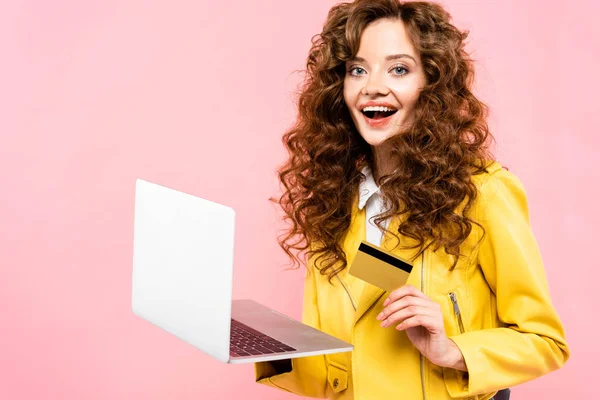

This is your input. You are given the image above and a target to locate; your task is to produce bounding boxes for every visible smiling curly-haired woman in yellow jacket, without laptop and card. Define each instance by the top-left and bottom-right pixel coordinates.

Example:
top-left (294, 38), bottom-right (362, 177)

top-left (256, 0), bottom-right (569, 400)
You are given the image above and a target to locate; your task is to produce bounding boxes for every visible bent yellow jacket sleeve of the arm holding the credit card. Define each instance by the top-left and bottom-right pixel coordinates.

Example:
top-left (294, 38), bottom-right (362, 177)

top-left (443, 169), bottom-right (570, 397)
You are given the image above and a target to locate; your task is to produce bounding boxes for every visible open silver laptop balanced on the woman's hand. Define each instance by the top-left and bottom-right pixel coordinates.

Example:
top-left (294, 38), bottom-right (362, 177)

top-left (132, 179), bottom-right (353, 364)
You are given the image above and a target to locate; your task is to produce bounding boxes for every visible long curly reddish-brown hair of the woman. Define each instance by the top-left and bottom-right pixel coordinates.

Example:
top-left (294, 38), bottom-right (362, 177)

top-left (276, 0), bottom-right (493, 279)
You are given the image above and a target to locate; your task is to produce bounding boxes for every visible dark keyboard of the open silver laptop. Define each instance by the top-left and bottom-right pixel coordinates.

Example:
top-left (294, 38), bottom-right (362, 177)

top-left (229, 319), bottom-right (296, 357)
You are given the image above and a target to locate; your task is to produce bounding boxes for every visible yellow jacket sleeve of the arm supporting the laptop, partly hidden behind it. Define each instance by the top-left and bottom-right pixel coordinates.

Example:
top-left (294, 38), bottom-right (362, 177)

top-left (255, 264), bottom-right (327, 398)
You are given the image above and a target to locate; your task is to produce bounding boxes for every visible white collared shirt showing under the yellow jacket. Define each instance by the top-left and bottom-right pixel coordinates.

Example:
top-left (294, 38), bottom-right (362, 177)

top-left (358, 167), bottom-right (390, 246)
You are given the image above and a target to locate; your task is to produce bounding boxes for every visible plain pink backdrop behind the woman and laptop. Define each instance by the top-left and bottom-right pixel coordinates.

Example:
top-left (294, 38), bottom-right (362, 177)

top-left (0, 0), bottom-right (600, 399)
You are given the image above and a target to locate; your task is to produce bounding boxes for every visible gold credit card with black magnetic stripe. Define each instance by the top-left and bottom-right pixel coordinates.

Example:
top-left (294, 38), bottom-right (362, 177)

top-left (348, 241), bottom-right (412, 292)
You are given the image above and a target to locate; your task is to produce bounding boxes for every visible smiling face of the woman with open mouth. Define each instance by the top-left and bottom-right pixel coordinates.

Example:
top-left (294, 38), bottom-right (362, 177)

top-left (344, 19), bottom-right (427, 147)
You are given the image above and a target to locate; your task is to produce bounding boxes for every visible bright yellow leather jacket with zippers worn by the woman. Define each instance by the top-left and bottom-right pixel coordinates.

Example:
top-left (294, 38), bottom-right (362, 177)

top-left (255, 163), bottom-right (569, 400)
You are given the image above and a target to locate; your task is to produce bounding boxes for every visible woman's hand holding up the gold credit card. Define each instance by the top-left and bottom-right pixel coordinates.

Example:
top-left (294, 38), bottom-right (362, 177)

top-left (377, 285), bottom-right (467, 371)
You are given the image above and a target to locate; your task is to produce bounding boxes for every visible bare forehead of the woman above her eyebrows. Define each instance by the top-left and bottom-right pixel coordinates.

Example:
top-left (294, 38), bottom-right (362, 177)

top-left (357, 19), bottom-right (419, 60)
